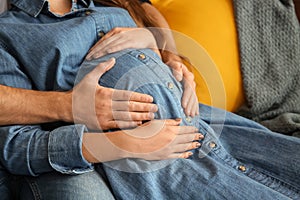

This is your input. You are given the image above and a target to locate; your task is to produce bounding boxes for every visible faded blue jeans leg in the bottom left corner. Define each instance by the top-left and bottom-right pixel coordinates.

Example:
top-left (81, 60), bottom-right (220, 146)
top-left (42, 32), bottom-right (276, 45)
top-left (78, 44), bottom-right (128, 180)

top-left (0, 170), bottom-right (114, 200)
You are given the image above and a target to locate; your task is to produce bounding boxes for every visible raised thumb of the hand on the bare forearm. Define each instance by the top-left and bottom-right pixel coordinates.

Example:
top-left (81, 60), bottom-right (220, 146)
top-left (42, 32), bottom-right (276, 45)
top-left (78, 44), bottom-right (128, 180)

top-left (87, 58), bottom-right (116, 81)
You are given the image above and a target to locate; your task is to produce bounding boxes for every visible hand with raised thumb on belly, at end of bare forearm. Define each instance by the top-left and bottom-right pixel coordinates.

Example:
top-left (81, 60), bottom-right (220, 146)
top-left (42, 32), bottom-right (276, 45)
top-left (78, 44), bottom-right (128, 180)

top-left (72, 59), bottom-right (158, 130)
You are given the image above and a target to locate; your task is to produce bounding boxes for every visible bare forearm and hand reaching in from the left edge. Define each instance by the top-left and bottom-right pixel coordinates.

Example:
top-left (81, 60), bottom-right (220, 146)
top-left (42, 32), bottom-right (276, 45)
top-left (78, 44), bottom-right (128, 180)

top-left (0, 62), bottom-right (157, 130)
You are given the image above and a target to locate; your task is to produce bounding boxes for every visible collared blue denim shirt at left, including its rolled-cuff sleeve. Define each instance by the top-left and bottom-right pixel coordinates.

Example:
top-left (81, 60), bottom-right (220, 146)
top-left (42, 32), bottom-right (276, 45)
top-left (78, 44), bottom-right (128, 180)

top-left (0, 0), bottom-right (135, 176)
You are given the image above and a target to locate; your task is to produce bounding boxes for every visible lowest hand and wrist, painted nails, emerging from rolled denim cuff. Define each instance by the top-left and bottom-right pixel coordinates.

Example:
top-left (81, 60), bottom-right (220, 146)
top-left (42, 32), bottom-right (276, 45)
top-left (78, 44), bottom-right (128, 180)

top-left (83, 120), bottom-right (204, 163)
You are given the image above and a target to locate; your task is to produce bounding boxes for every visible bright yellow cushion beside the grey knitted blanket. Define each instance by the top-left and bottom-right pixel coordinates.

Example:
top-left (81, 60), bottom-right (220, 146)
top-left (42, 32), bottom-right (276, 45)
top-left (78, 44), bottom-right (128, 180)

top-left (152, 0), bottom-right (244, 111)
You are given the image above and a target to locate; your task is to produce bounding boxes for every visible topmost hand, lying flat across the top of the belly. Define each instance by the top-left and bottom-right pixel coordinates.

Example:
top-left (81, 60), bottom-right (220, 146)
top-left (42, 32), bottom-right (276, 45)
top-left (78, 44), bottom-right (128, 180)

top-left (86, 28), bottom-right (160, 60)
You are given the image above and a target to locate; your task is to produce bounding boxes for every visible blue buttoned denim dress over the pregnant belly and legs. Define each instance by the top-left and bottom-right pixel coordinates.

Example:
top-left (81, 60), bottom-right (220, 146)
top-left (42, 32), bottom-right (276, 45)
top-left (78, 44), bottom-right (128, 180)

top-left (79, 50), bottom-right (300, 199)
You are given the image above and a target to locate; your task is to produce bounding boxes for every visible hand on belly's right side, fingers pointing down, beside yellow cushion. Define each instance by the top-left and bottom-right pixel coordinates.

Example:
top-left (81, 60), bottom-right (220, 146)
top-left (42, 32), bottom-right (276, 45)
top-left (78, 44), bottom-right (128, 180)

top-left (162, 51), bottom-right (199, 117)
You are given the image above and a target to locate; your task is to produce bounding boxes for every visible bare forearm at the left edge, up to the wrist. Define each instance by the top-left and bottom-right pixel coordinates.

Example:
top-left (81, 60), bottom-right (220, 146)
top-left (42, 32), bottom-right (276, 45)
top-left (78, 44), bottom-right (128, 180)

top-left (0, 85), bottom-right (73, 125)
